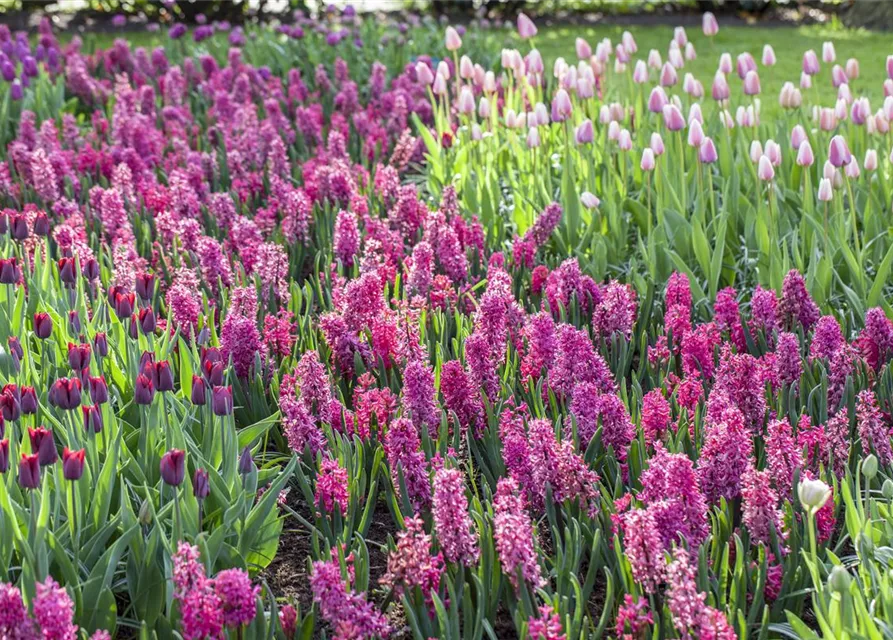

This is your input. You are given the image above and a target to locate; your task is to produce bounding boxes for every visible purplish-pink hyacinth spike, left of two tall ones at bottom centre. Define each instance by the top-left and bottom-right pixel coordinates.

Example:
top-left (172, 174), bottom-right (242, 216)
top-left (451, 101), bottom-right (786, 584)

top-left (432, 468), bottom-right (480, 566)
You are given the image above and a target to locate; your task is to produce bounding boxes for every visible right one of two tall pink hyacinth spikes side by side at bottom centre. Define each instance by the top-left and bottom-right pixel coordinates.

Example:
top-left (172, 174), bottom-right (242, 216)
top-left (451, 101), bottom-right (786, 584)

top-left (493, 478), bottom-right (545, 590)
